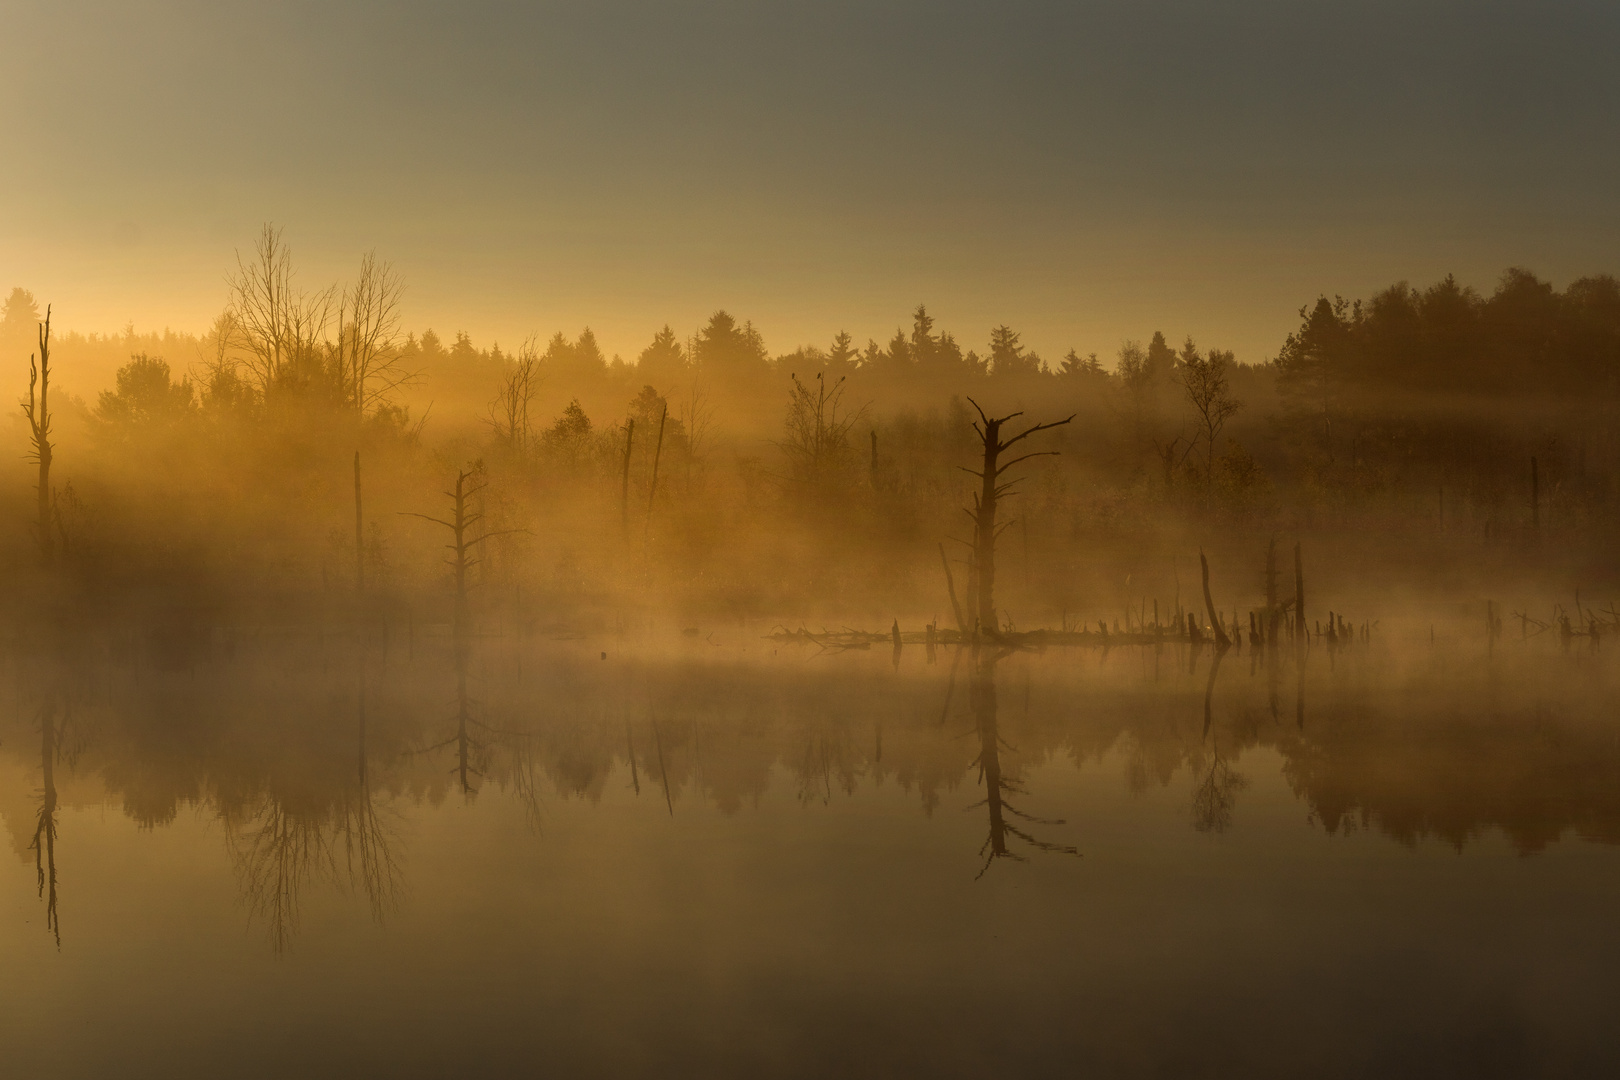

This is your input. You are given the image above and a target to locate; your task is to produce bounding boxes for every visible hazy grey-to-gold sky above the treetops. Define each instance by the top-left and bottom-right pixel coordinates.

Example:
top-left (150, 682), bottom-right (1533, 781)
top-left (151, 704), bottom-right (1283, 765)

top-left (0, 0), bottom-right (1620, 361)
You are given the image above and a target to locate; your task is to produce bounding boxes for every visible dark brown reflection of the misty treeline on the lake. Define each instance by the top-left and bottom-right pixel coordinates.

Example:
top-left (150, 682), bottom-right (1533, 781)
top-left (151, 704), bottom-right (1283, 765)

top-left (0, 631), bottom-right (1620, 950)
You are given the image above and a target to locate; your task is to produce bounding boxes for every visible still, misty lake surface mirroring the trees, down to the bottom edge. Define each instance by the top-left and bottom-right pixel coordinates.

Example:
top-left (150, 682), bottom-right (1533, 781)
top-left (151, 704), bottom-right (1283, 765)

top-left (0, 630), bottom-right (1620, 1077)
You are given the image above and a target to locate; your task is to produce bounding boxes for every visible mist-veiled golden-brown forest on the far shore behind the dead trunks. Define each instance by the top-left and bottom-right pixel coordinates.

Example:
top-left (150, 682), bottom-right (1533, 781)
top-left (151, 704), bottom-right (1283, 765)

top-left (0, 227), bottom-right (1620, 627)
